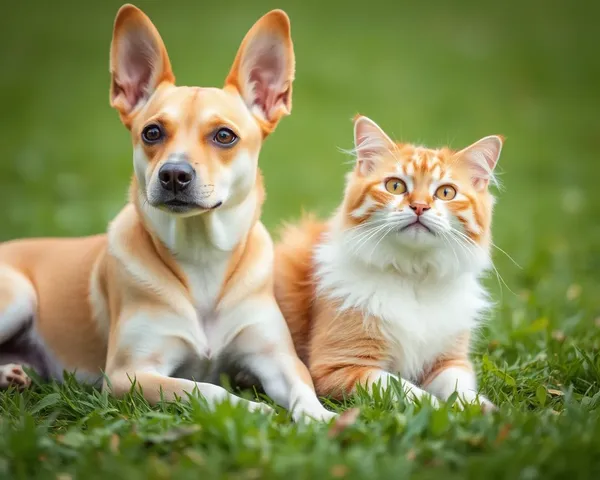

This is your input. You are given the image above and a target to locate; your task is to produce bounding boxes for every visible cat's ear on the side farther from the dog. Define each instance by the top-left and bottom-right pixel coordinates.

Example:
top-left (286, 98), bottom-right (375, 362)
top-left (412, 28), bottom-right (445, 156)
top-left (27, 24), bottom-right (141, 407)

top-left (456, 135), bottom-right (504, 191)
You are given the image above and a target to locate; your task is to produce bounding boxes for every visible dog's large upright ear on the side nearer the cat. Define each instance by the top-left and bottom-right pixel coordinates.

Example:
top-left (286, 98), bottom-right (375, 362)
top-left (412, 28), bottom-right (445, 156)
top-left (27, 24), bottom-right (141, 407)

top-left (225, 10), bottom-right (295, 134)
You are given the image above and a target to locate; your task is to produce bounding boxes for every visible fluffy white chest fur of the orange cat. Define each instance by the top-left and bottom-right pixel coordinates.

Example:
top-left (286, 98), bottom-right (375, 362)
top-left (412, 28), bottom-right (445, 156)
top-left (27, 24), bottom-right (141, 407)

top-left (315, 239), bottom-right (489, 380)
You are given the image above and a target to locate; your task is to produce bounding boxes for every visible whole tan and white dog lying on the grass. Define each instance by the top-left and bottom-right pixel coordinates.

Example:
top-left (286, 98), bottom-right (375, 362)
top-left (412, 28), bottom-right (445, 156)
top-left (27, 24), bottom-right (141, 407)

top-left (0, 5), bottom-right (334, 420)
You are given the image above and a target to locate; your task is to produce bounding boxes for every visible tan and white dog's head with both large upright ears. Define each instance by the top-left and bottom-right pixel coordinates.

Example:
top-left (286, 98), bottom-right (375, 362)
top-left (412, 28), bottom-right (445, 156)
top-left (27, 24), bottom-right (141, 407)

top-left (110, 5), bottom-right (294, 215)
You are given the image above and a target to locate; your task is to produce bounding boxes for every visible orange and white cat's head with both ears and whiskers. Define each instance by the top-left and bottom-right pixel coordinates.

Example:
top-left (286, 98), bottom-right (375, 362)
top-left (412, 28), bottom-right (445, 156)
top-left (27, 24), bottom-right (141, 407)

top-left (340, 116), bottom-right (503, 276)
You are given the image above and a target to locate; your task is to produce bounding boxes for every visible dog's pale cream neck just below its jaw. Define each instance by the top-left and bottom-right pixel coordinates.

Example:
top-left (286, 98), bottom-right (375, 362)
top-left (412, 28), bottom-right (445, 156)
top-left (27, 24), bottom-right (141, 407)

top-left (130, 172), bottom-right (264, 265)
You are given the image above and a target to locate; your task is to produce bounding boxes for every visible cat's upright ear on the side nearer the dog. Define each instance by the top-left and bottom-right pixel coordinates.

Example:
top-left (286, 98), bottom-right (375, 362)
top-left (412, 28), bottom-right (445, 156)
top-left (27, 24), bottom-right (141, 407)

top-left (354, 115), bottom-right (396, 175)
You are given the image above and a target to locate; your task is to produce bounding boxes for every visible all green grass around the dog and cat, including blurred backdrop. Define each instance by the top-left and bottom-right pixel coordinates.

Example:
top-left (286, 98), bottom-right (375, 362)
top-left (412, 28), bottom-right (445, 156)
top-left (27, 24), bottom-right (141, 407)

top-left (0, 0), bottom-right (600, 479)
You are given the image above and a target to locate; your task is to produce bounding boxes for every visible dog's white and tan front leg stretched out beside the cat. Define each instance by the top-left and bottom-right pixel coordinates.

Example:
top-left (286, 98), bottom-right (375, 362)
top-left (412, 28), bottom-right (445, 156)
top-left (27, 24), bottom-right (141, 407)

top-left (225, 297), bottom-right (336, 421)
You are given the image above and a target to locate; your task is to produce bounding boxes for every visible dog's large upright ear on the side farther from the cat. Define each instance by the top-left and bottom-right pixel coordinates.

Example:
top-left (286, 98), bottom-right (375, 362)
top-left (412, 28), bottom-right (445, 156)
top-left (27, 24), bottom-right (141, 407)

top-left (110, 5), bottom-right (175, 126)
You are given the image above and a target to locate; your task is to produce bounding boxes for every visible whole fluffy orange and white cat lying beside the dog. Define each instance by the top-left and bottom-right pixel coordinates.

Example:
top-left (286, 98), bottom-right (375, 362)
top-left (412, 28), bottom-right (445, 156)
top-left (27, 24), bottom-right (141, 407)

top-left (275, 116), bottom-right (503, 409)
